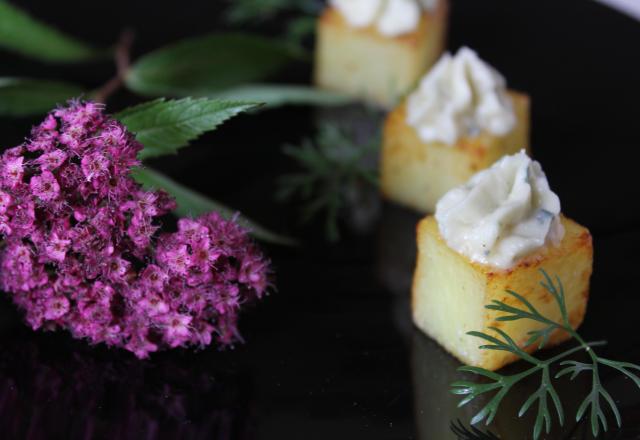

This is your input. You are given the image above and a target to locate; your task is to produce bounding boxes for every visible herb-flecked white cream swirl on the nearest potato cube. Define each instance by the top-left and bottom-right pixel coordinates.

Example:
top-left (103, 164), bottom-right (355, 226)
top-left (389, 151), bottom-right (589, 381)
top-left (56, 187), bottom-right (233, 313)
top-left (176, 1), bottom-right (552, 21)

top-left (436, 151), bottom-right (564, 269)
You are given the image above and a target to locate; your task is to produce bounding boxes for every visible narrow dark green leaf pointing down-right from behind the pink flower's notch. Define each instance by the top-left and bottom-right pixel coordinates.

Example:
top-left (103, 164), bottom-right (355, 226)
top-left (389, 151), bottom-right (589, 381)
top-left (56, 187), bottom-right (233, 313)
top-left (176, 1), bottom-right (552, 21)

top-left (133, 168), bottom-right (296, 246)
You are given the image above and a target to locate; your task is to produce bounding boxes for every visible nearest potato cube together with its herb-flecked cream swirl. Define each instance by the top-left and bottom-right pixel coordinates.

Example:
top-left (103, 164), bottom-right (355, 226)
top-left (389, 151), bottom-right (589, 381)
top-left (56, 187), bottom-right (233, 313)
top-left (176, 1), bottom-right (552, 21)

top-left (412, 151), bottom-right (593, 370)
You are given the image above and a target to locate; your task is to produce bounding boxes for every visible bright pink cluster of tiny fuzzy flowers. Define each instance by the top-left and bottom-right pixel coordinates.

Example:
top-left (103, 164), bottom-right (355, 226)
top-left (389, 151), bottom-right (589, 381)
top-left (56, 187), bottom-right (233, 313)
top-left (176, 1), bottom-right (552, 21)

top-left (0, 101), bottom-right (269, 358)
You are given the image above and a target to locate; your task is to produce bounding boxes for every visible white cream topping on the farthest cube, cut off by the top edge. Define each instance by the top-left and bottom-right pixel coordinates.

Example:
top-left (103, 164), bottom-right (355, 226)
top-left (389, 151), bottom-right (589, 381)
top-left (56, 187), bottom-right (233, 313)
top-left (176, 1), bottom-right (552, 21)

top-left (329, 0), bottom-right (437, 37)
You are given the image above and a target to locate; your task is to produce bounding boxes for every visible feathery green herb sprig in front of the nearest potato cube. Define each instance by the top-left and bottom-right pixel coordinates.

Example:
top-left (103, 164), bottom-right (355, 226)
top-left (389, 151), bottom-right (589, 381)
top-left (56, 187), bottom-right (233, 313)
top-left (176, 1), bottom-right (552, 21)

top-left (451, 270), bottom-right (640, 439)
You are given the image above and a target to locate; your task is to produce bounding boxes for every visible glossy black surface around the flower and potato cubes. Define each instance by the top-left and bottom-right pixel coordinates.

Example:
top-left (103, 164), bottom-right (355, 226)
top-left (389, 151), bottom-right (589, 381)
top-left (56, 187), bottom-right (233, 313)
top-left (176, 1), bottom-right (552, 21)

top-left (0, 0), bottom-right (640, 440)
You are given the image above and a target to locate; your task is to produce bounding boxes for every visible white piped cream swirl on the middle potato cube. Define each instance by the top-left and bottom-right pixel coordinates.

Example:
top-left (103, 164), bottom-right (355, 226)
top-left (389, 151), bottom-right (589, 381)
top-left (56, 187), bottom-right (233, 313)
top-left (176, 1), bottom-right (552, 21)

top-left (407, 47), bottom-right (516, 145)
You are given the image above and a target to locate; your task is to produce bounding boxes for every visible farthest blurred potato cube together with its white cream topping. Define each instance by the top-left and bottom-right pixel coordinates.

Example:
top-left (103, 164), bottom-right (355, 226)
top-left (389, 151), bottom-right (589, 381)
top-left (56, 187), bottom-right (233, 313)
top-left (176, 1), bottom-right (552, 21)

top-left (315, 0), bottom-right (448, 108)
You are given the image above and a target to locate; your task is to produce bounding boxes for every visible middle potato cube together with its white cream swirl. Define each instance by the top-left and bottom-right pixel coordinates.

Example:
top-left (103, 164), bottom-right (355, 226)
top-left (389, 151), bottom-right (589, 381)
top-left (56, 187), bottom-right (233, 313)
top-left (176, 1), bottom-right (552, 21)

top-left (381, 47), bottom-right (529, 213)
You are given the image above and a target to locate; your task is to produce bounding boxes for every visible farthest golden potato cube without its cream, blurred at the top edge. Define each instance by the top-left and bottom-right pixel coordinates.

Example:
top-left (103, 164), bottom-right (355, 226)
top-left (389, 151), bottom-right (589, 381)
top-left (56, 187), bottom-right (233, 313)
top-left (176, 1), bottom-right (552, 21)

top-left (315, 0), bottom-right (448, 108)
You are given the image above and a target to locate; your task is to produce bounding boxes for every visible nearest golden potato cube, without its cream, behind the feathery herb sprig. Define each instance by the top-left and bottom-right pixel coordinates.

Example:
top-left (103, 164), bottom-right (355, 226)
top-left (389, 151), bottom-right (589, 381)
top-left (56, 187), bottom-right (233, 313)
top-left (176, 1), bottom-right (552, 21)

top-left (411, 216), bottom-right (593, 370)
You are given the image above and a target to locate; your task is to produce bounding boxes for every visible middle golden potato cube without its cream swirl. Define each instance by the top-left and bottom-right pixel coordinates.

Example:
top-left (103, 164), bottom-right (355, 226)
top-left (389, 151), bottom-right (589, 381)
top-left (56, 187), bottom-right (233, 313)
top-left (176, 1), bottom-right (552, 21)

top-left (380, 91), bottom-right (529, 213)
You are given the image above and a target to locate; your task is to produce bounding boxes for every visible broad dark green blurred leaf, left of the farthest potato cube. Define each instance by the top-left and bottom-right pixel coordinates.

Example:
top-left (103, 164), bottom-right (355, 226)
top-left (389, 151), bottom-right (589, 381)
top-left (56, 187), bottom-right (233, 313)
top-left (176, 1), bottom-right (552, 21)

top-left (125, 34), bottom-right (306, 97)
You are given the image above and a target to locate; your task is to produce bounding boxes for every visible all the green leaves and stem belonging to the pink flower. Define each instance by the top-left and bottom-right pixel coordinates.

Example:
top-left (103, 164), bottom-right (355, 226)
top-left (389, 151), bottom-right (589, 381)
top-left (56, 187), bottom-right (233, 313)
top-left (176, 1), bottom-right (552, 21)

top-left (0, 6), bottom-right (320, 248)
